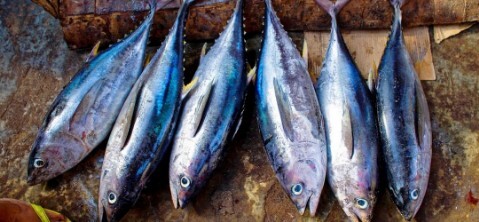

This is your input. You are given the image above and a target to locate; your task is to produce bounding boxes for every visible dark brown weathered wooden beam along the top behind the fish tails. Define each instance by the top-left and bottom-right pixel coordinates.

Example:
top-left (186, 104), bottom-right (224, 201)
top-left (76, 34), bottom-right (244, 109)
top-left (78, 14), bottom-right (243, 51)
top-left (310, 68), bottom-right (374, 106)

top-left (34, 0), bottom-right (479, 48)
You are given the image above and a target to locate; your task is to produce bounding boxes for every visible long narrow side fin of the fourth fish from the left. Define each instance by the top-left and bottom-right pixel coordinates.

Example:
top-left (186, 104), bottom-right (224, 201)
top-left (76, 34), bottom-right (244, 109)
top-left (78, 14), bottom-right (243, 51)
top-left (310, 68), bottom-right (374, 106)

top-left (273, 78), bottom-right (294, 141)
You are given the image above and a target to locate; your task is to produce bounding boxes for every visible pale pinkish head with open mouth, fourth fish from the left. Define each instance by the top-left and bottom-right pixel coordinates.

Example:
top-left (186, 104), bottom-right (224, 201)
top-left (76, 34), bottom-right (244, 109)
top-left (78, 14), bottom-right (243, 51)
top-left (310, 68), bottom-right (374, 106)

top-left (279, 159), bottom-right (324, 216)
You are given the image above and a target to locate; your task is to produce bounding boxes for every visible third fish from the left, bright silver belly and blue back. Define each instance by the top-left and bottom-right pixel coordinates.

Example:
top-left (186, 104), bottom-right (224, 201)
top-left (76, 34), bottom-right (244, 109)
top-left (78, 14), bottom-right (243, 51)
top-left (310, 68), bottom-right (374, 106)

top-left (169, 0), bottom-right (247, 208)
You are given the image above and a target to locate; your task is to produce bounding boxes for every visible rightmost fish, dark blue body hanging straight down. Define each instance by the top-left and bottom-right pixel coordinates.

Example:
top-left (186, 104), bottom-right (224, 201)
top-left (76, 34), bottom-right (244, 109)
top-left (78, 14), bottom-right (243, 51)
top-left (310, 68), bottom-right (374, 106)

top-left (376, 0), bottom-right (432, 220)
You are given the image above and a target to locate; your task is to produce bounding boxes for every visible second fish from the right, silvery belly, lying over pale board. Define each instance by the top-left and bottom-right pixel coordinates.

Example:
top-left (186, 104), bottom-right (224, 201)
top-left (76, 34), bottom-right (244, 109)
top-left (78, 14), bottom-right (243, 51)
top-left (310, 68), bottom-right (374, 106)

top-left (315, 0), bottom-right (379, 221)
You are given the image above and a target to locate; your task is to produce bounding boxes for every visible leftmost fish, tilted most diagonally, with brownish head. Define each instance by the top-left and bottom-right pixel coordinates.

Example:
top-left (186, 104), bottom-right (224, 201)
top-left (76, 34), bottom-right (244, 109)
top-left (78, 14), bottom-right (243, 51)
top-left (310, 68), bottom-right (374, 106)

top-left (27, 0), bottom-right (164, 185)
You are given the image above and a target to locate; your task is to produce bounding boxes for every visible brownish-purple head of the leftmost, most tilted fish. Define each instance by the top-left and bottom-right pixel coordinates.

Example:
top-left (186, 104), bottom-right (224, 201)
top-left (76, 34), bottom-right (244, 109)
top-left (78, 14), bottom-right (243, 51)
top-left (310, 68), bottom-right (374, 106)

top-left (27, 133), bottom-right (88, 185)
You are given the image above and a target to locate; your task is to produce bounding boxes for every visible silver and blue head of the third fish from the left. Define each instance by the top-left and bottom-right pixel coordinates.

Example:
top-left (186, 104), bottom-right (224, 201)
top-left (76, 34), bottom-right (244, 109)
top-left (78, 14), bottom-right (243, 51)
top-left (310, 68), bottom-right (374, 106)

top-left (169, 141), bottom-right (213, 208)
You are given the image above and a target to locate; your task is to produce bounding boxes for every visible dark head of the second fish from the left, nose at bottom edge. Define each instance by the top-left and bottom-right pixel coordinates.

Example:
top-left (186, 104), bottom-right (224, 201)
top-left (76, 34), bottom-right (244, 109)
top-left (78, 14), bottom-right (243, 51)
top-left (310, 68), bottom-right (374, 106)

top-left (98, 166), bottom-right (137, 221)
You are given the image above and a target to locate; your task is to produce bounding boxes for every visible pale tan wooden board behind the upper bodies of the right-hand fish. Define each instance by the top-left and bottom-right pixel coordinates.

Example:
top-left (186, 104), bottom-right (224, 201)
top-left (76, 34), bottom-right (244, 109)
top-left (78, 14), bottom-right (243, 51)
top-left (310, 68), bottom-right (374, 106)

top-left (304, 27), bottom-right (436, 80)
